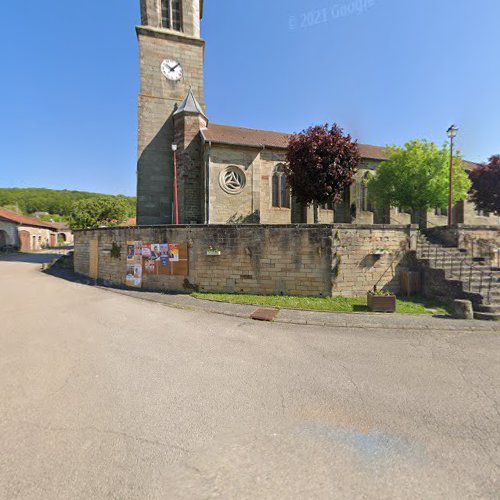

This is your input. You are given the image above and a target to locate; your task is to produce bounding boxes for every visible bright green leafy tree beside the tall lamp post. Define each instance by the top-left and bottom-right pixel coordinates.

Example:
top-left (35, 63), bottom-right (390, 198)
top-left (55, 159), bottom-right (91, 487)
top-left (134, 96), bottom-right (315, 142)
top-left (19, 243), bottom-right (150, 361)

top-left (368, 140), bottom-right (471, 213)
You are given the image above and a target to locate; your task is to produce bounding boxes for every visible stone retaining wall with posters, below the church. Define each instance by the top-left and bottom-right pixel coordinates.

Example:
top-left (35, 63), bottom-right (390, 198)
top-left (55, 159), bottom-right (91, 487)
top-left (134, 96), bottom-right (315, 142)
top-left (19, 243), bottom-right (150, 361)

top-left (75, 224), bottom-right (417, 296)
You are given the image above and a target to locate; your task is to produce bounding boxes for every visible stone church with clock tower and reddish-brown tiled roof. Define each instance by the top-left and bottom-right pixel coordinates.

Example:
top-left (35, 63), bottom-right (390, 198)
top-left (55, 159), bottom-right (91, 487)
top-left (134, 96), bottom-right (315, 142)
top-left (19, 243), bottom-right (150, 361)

top-left (136, 0), bottom-right (499, 226)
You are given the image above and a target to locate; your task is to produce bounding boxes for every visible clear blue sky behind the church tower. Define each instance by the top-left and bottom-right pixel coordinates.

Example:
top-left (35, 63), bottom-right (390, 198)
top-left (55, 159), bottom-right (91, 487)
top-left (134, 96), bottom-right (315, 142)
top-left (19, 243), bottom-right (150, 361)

top-left (0, 0), bottom-right (500, 195)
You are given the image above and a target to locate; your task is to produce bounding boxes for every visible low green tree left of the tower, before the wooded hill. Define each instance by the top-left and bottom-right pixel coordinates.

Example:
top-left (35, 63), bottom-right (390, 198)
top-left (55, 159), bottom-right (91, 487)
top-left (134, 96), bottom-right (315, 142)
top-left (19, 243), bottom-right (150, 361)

top-left (70, 197), bottom-right (128, 229)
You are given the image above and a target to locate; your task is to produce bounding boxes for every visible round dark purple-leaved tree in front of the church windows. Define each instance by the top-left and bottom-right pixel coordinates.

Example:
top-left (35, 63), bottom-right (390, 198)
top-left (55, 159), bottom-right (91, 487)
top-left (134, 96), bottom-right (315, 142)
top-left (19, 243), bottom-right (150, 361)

top-left (286, 124), bottom-right (361, 219)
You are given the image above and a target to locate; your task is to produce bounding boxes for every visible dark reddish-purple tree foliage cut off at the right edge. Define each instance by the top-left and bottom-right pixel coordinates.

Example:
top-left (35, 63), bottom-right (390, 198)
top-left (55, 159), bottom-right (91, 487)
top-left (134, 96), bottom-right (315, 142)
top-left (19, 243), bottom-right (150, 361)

top-left (470, 155), bottom-right (500, 215)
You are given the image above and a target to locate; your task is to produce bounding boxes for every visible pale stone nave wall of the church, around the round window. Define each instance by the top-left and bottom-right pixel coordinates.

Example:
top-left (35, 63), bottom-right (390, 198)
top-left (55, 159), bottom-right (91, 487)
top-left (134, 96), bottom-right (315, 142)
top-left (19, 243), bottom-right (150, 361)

top-left (203, 145), bottom-right (500, 227)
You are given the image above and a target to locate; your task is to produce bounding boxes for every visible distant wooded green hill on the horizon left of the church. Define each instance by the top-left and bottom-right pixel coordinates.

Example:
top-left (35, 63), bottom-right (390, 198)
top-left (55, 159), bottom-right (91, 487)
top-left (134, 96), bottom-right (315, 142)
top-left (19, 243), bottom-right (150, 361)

top-left (0, 188), bottom-right (135, 220)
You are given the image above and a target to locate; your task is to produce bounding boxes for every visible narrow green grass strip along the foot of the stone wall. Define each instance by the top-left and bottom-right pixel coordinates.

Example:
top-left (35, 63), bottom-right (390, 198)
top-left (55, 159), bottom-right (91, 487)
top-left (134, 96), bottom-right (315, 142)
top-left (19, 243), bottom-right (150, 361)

top-left (193, 292), bottom-right (448, 314)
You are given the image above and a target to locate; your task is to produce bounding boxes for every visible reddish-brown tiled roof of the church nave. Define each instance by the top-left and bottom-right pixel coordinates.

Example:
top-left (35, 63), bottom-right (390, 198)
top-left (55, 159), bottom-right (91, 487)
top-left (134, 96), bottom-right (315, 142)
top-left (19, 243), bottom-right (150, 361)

top-left (201, 123), bottom-right (478, 170)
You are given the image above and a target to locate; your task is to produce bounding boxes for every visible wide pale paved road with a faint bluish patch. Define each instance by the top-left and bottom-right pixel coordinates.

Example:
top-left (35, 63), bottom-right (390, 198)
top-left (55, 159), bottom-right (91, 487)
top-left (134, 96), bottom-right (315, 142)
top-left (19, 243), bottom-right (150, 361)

top-left (0, 256), bottom-right (500, 500)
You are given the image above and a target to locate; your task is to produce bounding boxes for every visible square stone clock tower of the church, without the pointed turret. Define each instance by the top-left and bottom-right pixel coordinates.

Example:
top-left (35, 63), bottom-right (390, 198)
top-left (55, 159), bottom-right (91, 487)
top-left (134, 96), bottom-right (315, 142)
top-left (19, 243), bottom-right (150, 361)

top-left (136, 0), bottom-right (205, 225)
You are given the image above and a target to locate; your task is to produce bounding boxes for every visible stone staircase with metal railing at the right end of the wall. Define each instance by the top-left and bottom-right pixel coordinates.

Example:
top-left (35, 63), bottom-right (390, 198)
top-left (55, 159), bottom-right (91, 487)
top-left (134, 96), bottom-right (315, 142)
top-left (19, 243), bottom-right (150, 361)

top-left (416, 234), bottom-right (500, 321)
